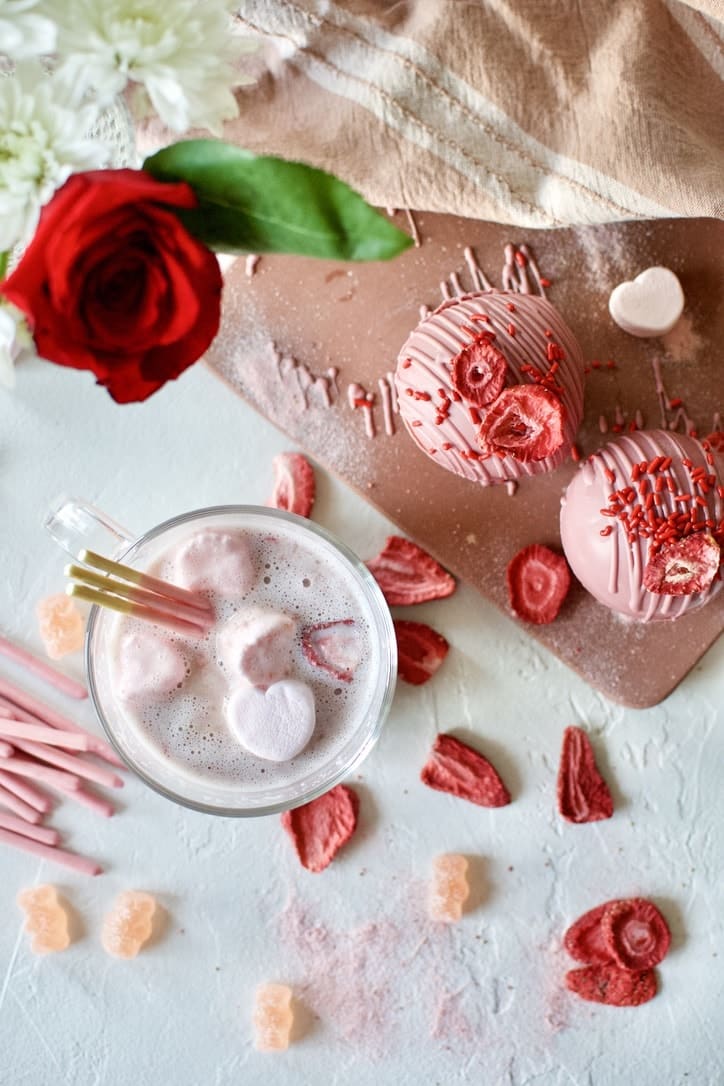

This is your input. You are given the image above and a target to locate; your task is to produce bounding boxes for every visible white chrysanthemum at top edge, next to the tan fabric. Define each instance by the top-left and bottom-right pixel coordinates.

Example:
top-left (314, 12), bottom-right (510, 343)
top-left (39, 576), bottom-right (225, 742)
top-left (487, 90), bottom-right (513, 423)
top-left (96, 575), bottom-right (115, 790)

top-left (48, 0), bottom-right (243, 135)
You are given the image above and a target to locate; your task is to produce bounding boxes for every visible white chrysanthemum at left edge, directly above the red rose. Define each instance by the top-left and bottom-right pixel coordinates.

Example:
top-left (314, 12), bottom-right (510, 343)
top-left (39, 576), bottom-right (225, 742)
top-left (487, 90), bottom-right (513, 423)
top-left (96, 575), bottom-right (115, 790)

top-left (0, 61), bottom-right (109, 252)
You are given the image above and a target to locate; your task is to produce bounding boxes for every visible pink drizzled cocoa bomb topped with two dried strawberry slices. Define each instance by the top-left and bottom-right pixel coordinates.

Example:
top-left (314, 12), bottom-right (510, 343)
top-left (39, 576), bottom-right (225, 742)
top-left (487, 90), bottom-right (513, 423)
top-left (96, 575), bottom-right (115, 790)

top-left (395, 290), bottom-right (583, 487)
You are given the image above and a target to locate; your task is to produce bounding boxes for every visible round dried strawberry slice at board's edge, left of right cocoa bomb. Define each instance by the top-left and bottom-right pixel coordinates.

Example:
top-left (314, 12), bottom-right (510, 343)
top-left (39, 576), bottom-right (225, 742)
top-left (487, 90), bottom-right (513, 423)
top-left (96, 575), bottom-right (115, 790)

top-left (506, 543), bottom-right (571, 626)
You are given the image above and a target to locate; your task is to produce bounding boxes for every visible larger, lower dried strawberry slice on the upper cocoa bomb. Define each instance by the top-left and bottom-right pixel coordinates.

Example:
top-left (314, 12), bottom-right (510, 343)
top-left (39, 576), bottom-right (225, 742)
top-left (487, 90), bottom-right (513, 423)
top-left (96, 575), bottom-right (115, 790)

top-left (477, 384), bottom-right (566, 464)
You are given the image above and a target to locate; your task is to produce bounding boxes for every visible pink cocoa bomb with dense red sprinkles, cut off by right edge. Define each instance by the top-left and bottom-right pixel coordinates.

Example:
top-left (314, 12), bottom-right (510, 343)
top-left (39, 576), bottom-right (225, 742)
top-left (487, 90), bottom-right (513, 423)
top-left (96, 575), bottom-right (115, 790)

top-left (560, 430), bottom-right (724, 622)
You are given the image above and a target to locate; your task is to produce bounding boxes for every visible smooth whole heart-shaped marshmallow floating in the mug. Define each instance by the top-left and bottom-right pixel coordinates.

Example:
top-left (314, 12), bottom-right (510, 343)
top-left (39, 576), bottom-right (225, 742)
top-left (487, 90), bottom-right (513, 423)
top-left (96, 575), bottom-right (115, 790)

top-left (226, 679), bottom-right (316, 761)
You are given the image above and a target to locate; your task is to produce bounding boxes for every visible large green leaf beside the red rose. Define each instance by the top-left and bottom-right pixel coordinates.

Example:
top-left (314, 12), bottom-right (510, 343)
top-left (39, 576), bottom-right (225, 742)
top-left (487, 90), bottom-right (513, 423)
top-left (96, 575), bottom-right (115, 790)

top-left (143, 139), bottom-right (412, 261)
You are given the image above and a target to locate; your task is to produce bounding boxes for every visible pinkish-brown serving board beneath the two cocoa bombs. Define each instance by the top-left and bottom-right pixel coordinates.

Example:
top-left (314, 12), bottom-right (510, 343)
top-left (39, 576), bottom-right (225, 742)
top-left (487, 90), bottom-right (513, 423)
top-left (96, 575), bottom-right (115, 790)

top-left (207, 213), bottom-right (724, 708)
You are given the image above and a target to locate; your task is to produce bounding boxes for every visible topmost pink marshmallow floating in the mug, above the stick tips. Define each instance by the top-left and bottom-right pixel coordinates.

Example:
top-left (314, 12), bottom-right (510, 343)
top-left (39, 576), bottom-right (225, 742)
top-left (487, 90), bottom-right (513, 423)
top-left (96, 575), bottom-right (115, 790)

top-left (173, 531), bottom-right (256, 599)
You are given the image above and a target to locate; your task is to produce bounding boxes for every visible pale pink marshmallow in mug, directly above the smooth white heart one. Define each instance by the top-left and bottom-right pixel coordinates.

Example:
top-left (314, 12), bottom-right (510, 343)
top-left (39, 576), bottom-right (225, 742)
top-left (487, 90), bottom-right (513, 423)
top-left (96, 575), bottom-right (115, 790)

top-left (216, 607), bottom-right (296, 686)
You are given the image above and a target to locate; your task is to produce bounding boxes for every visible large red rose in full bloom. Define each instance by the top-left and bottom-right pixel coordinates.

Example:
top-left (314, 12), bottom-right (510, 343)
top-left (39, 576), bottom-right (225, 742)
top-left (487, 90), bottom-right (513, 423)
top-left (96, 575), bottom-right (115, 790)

top-left (0, 169), bottom-right (221, 403)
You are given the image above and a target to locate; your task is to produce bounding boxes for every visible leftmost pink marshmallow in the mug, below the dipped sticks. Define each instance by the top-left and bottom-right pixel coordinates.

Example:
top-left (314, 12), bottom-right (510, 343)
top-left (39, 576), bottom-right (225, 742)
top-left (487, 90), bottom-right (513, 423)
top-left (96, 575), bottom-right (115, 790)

top-left (115, 630), bottom-right (188, 702)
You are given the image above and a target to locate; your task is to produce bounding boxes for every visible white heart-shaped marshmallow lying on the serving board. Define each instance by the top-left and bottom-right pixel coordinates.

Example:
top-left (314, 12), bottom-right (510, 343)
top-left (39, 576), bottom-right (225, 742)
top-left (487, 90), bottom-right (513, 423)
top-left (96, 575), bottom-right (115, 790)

top-left (608, 267), bottom-right (684, 339)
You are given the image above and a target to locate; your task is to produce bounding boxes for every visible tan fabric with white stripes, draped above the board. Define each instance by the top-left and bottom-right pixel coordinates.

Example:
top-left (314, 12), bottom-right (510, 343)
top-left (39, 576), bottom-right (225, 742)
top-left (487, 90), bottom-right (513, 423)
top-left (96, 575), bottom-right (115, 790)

top-left (227, 0), bottom-right (724, 227)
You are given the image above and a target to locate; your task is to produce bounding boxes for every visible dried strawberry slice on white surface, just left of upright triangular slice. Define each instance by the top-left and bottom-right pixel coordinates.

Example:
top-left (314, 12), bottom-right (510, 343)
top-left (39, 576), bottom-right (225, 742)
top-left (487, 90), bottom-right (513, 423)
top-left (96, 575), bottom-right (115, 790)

top-left (420, 735), bottom-right (510, 807)
